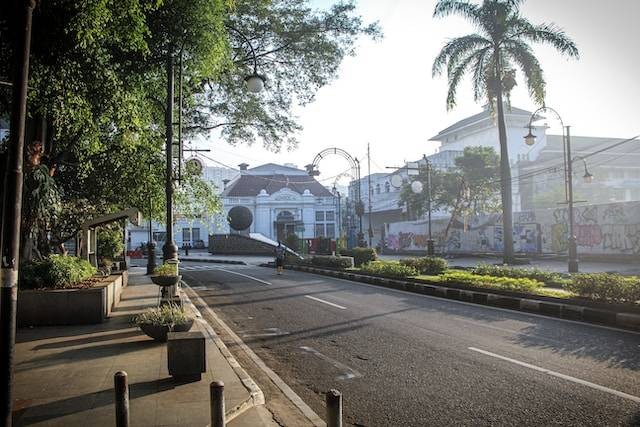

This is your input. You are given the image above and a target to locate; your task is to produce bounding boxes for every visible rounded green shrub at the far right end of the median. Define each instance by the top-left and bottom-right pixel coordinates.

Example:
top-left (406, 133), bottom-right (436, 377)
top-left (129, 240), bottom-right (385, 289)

top-left (564, 273), bottom-right (640, 304)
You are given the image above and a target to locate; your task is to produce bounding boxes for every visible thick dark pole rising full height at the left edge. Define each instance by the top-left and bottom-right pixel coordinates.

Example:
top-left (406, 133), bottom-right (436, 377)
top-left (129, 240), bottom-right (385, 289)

top-left (0, 0), bottom-right (36, 426)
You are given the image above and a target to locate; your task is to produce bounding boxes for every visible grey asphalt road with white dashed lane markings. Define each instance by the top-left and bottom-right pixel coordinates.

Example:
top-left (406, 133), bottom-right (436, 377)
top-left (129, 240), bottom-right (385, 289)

top-left (181, 263), bottom-right (640, 426)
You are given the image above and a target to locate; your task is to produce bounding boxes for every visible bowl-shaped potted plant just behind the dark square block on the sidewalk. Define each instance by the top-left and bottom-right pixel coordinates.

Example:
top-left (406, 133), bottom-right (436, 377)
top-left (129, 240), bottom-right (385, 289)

top-left (133, 304), bottom-right (193, 342)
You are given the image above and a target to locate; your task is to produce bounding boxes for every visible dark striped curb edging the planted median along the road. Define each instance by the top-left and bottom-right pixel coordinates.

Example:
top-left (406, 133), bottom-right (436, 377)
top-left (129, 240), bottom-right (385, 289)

top-left (286, 265), bottom-right (640, 331)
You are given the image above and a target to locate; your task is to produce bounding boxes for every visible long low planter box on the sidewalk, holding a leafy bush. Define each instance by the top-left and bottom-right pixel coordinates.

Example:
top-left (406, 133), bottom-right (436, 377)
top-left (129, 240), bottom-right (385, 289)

top-left (17, 275), bottom-right (126, 326)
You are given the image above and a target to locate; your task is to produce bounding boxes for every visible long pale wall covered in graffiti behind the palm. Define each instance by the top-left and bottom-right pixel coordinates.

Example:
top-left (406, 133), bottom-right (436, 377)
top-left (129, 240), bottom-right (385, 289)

top-left (386, 202), bottom-right (640, 255)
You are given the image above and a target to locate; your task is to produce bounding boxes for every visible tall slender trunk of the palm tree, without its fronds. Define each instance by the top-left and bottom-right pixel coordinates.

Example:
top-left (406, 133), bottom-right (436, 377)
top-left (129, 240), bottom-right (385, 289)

top-left (495, 55), bottom-right (513, 264)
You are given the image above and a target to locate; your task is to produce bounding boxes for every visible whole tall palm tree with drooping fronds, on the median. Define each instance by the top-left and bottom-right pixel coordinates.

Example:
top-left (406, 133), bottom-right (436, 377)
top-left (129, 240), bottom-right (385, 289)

top-left (433, 0), bottom-right (578, 264)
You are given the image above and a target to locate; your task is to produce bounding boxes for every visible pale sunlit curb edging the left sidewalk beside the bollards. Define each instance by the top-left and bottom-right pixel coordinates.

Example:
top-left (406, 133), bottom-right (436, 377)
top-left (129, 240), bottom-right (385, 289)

top-left (181, 281), bottom-right (265, 422)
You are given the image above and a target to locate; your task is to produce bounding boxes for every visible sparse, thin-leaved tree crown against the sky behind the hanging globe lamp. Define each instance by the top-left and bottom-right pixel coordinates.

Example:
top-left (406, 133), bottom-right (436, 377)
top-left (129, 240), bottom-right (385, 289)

top-left (187, 0), bottom-right (381, 151)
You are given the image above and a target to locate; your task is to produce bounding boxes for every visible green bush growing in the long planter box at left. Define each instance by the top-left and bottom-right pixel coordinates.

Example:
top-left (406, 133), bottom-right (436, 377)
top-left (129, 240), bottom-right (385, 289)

top-left (20, 255), bottom-right (96, 289)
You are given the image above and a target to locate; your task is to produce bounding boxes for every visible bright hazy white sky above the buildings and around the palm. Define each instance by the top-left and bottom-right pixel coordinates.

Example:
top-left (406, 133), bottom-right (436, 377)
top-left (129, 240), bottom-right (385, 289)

top-left (197, 0), bottom-right (640, 185)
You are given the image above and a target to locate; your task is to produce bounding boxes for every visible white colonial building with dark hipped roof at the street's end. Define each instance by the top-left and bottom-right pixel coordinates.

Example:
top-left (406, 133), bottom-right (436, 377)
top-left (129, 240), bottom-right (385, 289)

top-left (221, 163), bottom-right (337, 240)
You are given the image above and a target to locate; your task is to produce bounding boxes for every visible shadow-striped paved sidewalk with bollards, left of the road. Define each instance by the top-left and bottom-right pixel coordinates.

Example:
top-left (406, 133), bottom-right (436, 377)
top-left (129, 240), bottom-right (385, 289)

top-left (14, 268), bottom-right (276, 426)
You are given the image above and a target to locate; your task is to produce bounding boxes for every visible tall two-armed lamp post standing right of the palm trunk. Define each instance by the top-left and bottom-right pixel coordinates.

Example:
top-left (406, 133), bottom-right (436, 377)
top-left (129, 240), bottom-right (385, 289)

top-left (524, 107), bottom-right (593, 273)
